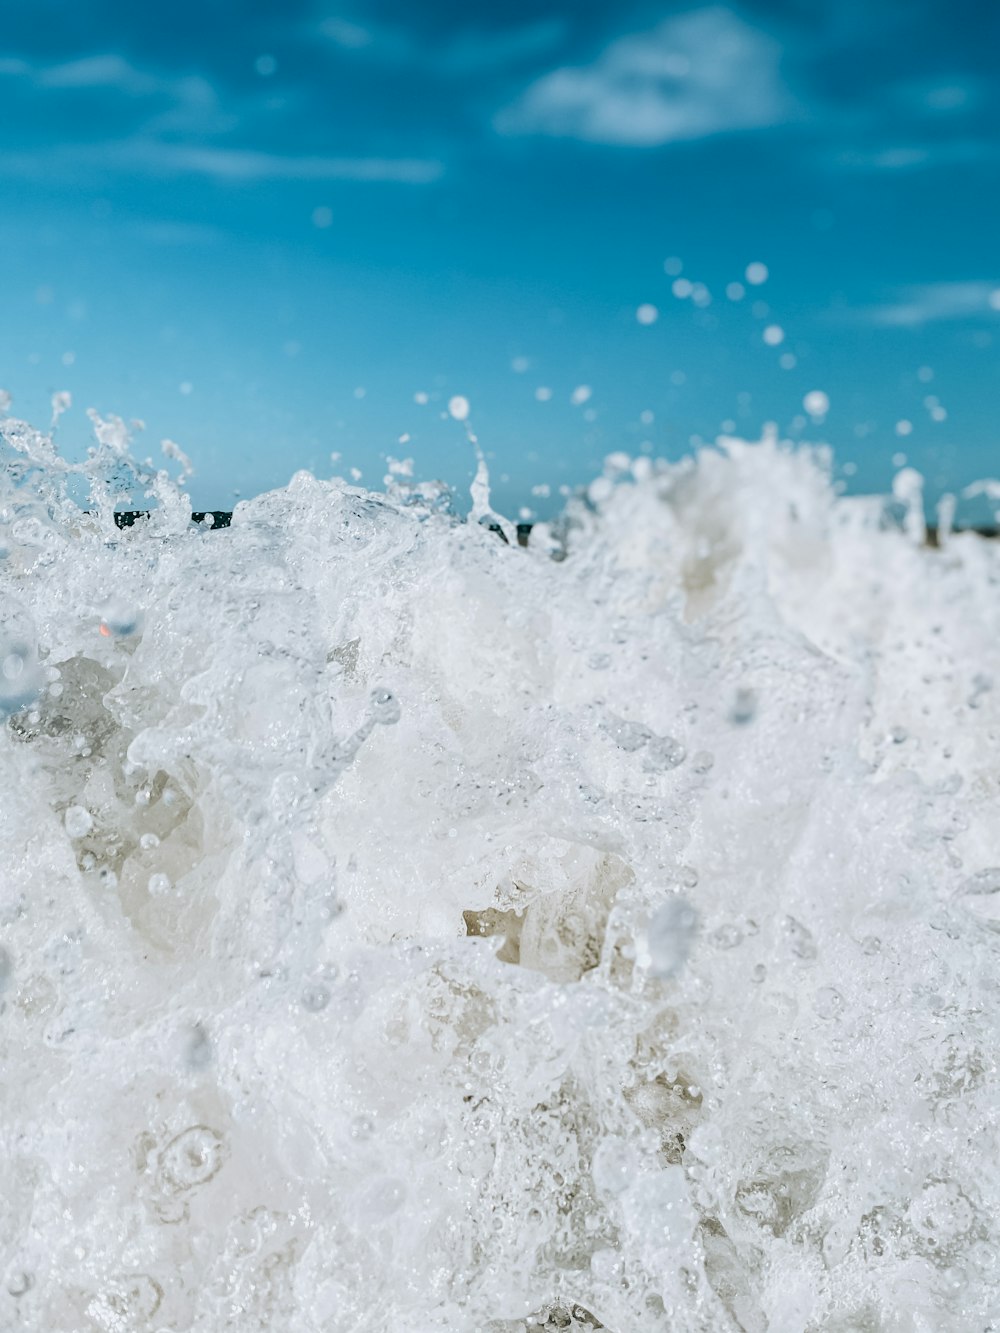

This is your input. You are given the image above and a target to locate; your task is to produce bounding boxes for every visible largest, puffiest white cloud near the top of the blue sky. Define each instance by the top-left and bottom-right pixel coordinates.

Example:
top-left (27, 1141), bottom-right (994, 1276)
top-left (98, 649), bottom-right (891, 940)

top-left (495, 5), bottom-right (793, 148)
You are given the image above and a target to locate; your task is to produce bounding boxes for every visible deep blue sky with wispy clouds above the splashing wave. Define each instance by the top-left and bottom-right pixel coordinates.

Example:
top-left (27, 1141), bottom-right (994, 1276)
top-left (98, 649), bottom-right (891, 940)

top-left (0, 0), bottom-right (1000, 515)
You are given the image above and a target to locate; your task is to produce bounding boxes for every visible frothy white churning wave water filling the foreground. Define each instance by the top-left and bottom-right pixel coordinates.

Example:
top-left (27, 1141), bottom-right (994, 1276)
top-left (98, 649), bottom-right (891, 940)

top-left (0, 399), bottom-right (1000, 1333)
